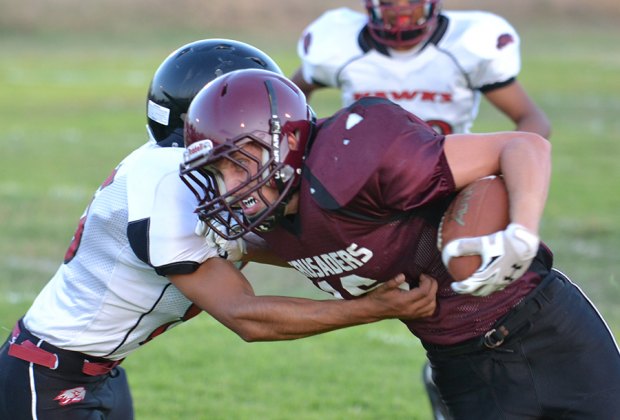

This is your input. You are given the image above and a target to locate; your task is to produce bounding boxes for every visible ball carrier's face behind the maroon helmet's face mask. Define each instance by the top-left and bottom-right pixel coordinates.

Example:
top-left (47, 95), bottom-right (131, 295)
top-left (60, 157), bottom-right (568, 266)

top-left (213, 143), bottom-right (278, 217)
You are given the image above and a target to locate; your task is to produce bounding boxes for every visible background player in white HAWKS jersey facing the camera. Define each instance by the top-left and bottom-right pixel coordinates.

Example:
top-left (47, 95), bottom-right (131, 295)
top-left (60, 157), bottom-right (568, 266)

top-left (292, 0), bottom-right (550, 137)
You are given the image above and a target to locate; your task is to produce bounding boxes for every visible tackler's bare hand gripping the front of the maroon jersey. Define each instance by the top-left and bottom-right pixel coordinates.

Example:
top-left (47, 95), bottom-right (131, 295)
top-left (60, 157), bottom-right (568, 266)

top-left (367, 274), bottom-right (437, 319)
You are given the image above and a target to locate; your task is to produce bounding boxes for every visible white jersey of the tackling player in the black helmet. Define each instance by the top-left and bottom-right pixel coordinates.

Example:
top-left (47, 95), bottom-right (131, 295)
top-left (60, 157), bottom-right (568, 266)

top-left (24, 141), bottom-right (217, 360)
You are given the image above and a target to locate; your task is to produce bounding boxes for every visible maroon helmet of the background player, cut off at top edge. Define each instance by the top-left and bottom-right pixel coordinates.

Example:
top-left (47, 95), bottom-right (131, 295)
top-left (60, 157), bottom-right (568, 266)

top-left (364, 0), bottom-right (441, 48)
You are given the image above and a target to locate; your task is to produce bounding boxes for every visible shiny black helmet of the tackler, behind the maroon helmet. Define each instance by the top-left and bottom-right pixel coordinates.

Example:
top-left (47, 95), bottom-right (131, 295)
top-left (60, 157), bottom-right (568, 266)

top-left (146, 39), bottom-right (282, 146)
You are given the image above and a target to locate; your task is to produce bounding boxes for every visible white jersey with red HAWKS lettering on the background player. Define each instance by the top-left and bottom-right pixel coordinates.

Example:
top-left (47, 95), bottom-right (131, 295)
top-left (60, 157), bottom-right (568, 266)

top-left (297, 8), bottom-right (521, 134)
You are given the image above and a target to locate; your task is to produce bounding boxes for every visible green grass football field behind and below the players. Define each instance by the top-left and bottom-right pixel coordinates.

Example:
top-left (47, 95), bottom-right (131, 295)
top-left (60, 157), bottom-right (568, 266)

top-left (0, 16), bottom-right (620, 419)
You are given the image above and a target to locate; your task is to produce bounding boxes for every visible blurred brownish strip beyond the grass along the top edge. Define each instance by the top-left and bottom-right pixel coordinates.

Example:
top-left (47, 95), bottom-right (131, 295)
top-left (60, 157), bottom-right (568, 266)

top-left (0, 0), bottom-right (620, 33)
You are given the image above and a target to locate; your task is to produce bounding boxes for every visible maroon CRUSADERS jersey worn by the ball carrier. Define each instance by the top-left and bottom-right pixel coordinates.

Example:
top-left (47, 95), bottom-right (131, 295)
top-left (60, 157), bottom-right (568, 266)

top-left (261, 99), bottom-right (540, 344)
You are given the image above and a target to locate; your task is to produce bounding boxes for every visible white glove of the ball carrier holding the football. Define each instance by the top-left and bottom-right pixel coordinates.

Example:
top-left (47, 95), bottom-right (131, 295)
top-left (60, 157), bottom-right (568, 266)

top-left (441, 223), bottom-right (540, 296)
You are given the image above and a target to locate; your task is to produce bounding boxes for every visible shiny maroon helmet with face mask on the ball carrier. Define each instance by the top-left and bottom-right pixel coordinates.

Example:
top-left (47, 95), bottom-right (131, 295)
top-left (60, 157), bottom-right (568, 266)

top-left (181, 69), bottom-right (315, 239)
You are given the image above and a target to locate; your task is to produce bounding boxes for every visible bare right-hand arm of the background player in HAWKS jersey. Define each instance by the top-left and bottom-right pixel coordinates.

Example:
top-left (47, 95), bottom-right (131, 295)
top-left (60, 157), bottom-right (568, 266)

top-left (485, 80), bottom-right (551, 138)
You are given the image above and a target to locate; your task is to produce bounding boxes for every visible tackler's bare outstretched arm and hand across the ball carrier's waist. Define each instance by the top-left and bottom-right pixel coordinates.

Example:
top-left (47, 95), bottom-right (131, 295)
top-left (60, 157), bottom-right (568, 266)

top-left (169, 258), bottom-right (437, 341)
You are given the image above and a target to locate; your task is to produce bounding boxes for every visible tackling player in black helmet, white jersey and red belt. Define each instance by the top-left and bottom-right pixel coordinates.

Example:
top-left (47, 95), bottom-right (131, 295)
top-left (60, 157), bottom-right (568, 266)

top-left (0, 39), bottom-right (436, 420)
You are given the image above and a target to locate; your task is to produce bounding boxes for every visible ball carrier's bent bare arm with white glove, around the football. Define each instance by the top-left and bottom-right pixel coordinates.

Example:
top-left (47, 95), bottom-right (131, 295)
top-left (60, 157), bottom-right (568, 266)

top-left (442, 132), bottom-right (551, 296)
